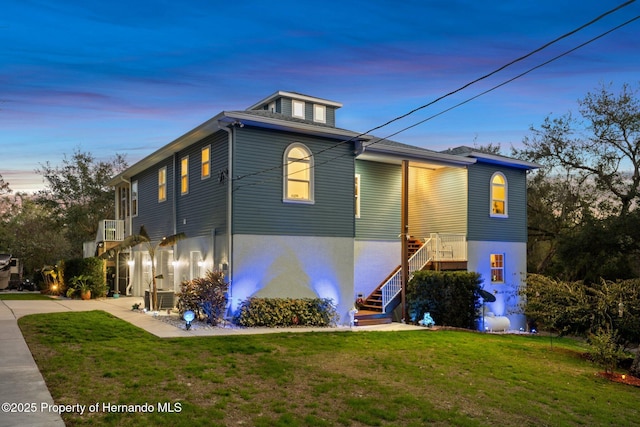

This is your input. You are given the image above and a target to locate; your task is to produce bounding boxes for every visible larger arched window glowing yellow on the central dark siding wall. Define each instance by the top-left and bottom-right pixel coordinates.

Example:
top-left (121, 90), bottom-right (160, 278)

top-left (283, 143), bottom-right (313, 203)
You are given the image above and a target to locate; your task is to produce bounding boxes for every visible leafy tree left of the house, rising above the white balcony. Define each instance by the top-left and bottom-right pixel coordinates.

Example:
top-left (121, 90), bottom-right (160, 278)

top-left (36, 149), bottom-right (127, 256)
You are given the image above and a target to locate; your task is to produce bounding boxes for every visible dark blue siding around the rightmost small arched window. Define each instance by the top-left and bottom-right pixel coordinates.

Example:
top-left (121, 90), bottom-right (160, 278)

top-left (467, 163), bottom-right (527, 242)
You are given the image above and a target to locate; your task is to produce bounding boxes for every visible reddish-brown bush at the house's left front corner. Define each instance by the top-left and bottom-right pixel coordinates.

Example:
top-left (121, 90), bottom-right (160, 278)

top-left (176, 271), bottom-right (229, 325)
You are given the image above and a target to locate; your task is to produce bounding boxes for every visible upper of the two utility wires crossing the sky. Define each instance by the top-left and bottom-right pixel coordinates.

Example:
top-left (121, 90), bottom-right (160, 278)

top-left (230, 0), bottom-right (636, 188)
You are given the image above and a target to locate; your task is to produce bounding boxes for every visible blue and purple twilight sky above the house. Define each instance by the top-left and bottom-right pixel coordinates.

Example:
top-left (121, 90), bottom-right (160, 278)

top-left (0, 0), bottom-right (640, 191)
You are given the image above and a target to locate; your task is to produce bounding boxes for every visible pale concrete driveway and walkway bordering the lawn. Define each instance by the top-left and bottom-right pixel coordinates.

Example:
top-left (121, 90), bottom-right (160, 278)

top-left (0, 297), bottom-right (424, 427)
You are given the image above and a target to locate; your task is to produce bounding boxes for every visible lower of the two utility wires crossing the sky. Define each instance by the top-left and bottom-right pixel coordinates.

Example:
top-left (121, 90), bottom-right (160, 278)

top-left (234, 15), bottom-right (640, 191)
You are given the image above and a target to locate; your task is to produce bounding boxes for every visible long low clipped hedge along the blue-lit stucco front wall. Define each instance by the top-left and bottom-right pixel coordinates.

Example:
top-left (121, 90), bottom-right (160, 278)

top-left (234, 298), bottom-right (338, 327)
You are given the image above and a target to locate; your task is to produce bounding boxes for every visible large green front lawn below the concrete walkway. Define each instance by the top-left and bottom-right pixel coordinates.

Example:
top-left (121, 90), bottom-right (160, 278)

top-left (19, 311), bottom-right (640, 427)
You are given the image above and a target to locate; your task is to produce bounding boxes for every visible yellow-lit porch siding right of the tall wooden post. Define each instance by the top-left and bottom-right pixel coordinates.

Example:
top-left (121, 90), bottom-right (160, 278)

top-left (409, 167), bottom-right (467, 239)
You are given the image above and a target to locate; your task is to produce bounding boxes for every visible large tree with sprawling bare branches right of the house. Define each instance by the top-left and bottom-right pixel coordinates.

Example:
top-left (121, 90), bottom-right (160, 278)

top-left (512, 84), bottom-right (640, 281)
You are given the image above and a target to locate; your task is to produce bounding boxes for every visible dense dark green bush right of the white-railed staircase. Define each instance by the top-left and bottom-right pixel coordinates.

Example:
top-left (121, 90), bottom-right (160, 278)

top-left (407, 270), bottom-right (482, 329)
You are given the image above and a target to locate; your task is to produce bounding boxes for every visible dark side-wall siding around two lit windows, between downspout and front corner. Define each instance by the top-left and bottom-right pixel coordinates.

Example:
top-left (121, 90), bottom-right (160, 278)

top-left (175, 131), bottom-right (228, 237)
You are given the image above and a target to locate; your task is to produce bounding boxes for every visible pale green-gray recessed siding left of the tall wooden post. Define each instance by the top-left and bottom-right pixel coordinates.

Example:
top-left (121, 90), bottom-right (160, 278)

top-left (356, 160), bottom-right (402, 240)
